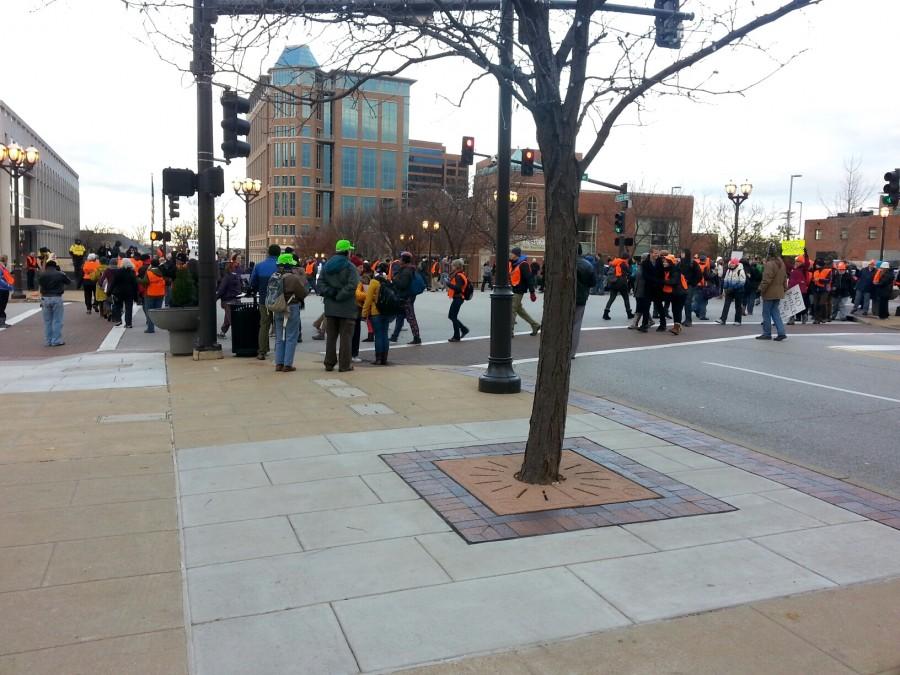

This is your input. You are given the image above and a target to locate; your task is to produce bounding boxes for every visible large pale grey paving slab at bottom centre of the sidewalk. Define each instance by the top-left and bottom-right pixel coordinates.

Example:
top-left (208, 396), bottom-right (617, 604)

top-left (334, 568), bottom-right (628, 671)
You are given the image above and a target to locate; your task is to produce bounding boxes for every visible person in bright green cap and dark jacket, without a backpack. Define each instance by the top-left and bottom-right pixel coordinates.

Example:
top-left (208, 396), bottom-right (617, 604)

top-left (318, 239), bottom-right (359, 373)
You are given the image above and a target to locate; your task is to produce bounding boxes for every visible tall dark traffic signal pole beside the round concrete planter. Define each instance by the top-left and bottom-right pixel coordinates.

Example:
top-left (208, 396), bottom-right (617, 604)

top-left (191, 0), bottom-right (222, 360)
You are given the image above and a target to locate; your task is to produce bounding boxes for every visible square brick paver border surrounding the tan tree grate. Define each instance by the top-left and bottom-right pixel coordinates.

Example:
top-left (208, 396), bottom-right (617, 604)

top-left (381, 437), bottom-right (737, 544)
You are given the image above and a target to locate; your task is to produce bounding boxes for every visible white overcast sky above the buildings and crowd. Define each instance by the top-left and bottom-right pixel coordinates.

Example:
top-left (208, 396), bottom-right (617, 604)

top-left (0, 0), bottom-right (900, 241)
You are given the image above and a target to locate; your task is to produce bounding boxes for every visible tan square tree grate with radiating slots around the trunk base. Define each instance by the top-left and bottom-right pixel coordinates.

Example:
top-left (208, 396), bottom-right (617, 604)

top-left (435, 450), bottom-right (660, 516)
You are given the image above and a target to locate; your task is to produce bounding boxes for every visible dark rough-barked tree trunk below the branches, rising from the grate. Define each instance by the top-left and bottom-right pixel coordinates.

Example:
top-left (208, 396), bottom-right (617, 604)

top-left (516, 139), bottom-right (581, 485)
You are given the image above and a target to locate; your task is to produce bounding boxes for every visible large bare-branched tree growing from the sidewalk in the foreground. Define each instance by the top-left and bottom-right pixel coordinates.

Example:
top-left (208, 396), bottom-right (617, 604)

top-left (126, 0), bottom-right (821, 484)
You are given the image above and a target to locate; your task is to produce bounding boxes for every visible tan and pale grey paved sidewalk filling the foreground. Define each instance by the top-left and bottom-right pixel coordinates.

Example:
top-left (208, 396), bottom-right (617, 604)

top-left (0, 352), bottom-right (900, 675)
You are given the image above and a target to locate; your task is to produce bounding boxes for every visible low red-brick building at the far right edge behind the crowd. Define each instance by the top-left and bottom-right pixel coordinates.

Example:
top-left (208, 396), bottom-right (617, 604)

top-left (804, 215), bottom-right (900, 262)
